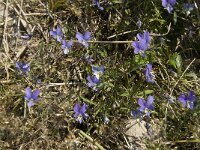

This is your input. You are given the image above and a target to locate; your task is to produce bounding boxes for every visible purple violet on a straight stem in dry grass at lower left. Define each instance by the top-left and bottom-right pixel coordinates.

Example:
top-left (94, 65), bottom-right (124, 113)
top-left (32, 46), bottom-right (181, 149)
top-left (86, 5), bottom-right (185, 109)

top-left (24, 87), bottom-right (40, 108)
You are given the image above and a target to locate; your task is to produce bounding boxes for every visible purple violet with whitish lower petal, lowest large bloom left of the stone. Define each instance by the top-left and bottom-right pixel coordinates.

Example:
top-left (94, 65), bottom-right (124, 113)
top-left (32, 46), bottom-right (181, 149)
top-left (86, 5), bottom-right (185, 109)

top-left (74, 103), bottom-right (88, 124)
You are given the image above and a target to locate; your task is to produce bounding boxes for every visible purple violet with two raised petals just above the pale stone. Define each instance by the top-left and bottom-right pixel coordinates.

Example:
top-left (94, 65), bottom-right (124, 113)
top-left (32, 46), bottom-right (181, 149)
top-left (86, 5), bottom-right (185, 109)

top-left (138, 96), bottom-right (154, 116)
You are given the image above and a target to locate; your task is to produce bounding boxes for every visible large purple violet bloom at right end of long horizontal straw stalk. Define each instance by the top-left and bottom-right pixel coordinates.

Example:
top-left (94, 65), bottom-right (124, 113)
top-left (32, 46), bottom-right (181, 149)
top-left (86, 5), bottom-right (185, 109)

top-left (132, 31), bottom-right (151, 57)
